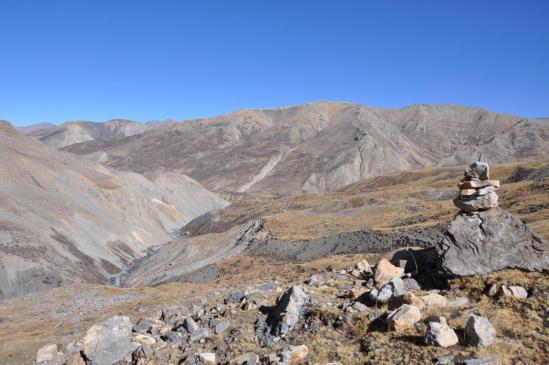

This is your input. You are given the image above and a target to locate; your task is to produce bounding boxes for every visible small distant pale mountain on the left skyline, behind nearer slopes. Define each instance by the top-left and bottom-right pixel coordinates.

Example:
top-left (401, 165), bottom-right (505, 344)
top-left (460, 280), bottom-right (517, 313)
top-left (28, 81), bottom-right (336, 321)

top-left (27, 119), bottom-right (147, 149)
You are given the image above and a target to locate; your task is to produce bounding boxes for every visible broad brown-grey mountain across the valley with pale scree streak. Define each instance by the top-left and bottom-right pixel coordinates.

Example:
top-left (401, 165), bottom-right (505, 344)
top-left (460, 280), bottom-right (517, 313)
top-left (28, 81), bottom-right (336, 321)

top-left (52, 103), bottom-right (549, 194)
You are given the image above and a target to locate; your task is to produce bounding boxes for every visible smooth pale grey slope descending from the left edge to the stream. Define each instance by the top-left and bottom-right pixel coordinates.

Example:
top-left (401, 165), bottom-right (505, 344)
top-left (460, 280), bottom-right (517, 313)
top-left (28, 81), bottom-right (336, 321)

top-left (0, 122), bottom-right (227, 298)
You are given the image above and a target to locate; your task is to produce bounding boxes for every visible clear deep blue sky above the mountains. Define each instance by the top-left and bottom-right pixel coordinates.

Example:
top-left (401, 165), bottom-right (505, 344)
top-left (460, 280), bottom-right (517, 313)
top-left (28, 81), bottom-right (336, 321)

top-left (0, 0), bottom-right (549, 125)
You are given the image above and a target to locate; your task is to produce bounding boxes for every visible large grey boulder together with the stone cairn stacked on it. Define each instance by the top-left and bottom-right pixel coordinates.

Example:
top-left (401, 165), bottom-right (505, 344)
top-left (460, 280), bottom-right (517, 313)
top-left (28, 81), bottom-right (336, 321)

top-left (435, 163), bottom-right (549, 276)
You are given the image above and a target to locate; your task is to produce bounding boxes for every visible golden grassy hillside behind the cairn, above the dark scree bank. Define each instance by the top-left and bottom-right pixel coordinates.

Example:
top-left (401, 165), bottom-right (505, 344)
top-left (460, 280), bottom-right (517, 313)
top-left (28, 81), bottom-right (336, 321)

top-left (252, 160), bottom-right (549, 240)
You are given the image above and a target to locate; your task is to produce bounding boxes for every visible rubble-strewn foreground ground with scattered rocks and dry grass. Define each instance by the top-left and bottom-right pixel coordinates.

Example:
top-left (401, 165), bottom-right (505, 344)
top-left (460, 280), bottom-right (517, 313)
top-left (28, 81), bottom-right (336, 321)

top-left (31, 251), bottom-right (549, 365)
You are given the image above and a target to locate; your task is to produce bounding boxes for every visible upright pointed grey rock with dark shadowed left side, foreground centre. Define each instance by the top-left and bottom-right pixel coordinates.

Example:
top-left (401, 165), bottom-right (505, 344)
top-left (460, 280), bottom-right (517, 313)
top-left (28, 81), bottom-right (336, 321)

top-left (267, 285), bottom-right (310, 336)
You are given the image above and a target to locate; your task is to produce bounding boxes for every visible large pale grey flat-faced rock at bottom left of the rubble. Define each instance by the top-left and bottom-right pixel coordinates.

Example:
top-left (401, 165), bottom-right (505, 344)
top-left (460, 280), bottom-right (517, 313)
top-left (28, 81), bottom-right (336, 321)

top-left (83, 316), bottom-right (137, 365)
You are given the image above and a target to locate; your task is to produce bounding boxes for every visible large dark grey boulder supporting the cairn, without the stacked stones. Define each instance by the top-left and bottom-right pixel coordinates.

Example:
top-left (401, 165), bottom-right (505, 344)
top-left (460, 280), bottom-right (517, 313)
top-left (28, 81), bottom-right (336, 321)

top-left (435, 208), bottom-right (549, 276)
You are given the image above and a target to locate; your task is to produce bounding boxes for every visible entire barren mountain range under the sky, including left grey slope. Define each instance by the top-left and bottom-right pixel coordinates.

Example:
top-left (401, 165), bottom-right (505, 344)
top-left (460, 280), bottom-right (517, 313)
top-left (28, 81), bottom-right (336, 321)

top-left (0, 102), bottom-right (549, 297)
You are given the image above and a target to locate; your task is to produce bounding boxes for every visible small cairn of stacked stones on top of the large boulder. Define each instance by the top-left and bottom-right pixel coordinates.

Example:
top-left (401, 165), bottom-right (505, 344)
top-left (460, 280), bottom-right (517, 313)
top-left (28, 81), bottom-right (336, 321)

top-left (454, 162), bottom-right (499, 214)
